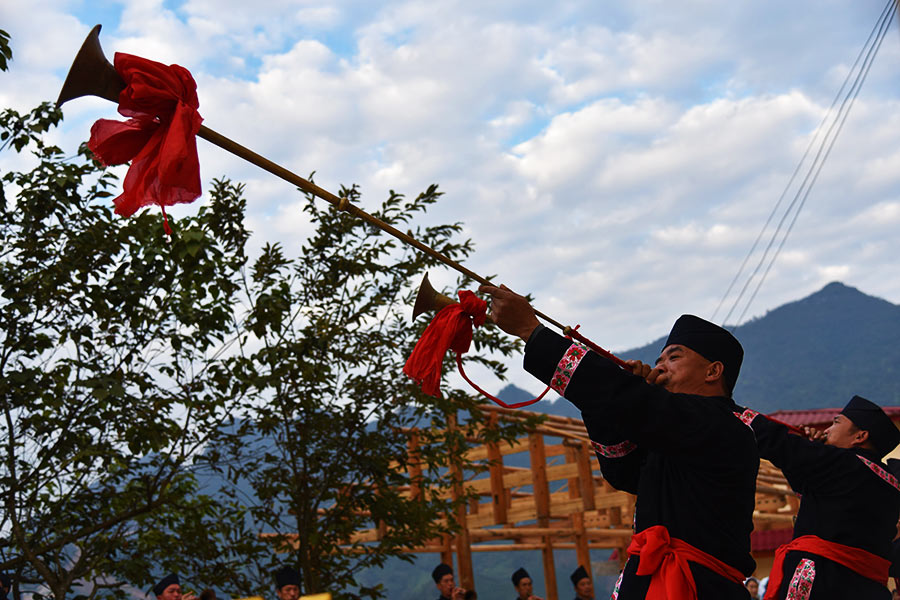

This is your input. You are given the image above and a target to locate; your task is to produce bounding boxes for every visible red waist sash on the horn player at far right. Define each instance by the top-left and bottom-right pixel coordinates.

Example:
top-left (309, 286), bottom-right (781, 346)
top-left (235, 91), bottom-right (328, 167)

top-left (765, 535), bottom-right (891, 600)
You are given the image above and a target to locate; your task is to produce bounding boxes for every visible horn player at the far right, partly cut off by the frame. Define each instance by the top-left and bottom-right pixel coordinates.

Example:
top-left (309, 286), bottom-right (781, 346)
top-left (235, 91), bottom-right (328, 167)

top-left (744, 396), bottom-right (900, 600)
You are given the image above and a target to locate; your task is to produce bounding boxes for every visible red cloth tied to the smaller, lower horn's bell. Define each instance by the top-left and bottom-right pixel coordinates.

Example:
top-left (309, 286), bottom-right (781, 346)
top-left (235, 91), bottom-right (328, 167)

top-left (403, 290), bottom-right (487, 396)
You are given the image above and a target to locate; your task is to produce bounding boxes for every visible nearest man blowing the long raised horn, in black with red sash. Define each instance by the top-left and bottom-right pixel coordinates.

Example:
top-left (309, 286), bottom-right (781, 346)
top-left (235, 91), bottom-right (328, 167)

top-left (480, 285), bottom-right (759, 600)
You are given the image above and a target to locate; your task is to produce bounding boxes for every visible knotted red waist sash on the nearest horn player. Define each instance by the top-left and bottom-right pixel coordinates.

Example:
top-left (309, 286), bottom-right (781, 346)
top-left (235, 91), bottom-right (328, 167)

top-left (628, 525), bottom-right (744, 600)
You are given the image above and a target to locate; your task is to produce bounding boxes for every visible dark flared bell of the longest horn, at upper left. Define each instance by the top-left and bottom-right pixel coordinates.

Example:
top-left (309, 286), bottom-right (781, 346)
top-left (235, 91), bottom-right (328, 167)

top-left (56, 25), bottom-right (125, 107)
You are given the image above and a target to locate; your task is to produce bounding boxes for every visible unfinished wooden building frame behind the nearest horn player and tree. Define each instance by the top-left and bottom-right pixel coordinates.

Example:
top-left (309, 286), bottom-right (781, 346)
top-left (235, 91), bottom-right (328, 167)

top-left (266, 405), bottom-right (799, 600)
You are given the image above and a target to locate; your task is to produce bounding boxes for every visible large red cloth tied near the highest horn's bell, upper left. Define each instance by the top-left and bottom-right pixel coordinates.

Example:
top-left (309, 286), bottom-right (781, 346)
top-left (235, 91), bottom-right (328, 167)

top-left (88, 52), bottom-right (203, 231)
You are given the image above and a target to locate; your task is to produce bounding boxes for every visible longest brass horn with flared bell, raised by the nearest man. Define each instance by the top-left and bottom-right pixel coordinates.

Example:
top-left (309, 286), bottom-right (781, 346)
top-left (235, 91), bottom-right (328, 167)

top-left (56, 25), bottom-right (571, 333)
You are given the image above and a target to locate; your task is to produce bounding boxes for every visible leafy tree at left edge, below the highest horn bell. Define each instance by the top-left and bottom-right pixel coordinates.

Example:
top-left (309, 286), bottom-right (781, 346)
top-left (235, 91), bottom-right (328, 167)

top-left (0, 104), bottom-right (247, 600)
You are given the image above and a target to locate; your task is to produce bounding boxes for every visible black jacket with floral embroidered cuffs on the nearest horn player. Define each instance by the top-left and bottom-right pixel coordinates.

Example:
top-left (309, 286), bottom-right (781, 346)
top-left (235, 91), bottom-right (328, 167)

top-left (525, 327), bottom-right (759, 600)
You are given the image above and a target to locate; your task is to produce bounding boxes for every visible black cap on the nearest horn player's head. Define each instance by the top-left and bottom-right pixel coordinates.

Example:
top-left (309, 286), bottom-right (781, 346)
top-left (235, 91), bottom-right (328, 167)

top-left (663, 315), bottom-right (744, 393)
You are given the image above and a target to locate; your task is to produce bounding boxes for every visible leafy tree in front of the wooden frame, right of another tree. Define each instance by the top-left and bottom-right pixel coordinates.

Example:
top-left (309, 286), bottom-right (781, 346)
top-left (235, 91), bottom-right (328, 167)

top-left (200, 180), bottom-right (522, 598)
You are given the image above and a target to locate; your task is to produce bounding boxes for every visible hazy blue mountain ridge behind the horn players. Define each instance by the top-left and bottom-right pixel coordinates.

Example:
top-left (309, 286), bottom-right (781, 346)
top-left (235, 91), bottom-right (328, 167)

top-left (498, 282), bottom-right (900, 417)
